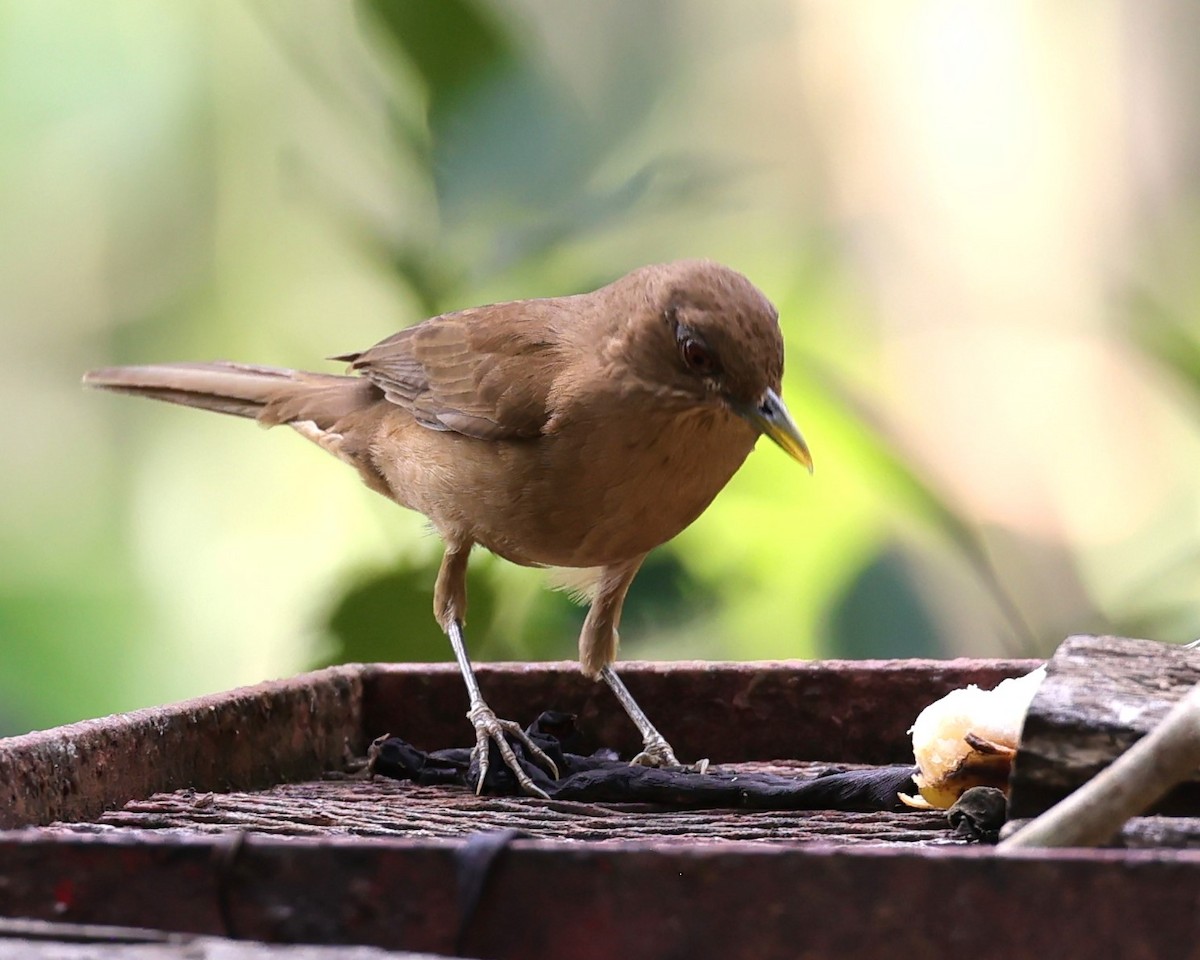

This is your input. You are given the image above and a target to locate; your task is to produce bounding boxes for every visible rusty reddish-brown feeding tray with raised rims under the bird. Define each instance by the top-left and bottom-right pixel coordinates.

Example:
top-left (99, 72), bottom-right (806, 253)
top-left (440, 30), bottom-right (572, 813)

top-left (0, 660), bottom-right (1200, 960)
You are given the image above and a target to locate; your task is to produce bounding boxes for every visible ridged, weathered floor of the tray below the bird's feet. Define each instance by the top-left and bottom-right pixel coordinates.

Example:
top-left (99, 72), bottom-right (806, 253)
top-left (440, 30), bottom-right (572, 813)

top-left (46, 763), bottom-right (962, 845)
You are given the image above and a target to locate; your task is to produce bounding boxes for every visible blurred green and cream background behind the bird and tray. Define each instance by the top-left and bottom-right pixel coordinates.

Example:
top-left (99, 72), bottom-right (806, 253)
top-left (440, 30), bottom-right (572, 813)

top-left (0, 0), bottom-right (1200, 733)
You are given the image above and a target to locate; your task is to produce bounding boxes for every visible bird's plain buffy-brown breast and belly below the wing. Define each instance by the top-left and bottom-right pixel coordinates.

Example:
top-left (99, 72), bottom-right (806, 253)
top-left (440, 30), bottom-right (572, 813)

top-left (372, 398), bottom-right (756, 566)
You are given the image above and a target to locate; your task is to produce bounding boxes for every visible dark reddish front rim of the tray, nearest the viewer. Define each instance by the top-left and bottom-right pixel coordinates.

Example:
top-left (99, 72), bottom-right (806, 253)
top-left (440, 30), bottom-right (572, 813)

top-left (0, 834), bottom-right (1200, 960)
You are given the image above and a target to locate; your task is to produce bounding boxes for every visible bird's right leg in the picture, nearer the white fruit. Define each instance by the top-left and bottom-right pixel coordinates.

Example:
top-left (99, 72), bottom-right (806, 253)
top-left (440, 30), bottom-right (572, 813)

top-left (580, 554), bottom-right (708, 773)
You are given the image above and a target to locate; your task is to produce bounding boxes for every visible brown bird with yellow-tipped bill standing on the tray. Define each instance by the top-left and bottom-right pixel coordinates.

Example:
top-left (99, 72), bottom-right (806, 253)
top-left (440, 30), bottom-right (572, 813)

top-left (84, 260), bottom-right (812, 796)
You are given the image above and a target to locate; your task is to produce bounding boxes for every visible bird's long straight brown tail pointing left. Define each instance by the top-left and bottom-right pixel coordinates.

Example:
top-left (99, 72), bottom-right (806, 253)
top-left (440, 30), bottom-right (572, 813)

top-left (83, 360), bottom-right (374, 430)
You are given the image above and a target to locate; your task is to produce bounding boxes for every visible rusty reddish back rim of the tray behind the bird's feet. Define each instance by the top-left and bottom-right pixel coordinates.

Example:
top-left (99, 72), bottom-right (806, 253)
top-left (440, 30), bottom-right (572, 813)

top-left (364, 659), bottom-right (1042, 764)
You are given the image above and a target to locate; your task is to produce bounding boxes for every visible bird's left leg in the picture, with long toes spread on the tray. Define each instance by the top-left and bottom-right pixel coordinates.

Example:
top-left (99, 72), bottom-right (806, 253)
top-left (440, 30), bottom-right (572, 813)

top-left (434, 544), bottom-right (558, 800)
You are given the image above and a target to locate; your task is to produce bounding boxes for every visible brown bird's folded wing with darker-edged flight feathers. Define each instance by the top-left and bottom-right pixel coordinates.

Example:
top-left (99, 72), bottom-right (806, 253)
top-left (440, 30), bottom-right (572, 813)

top-left (334, 301), bottom-right (562, 440)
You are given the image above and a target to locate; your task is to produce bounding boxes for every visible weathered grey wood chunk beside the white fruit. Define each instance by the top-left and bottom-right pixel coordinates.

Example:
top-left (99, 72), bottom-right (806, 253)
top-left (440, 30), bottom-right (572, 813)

top-left (1009, 636), bottom-right (1200, 818)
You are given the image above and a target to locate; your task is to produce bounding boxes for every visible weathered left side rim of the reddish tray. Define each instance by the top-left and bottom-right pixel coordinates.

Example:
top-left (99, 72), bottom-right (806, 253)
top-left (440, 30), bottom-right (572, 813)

top-left (0, 666), bottom-right (365, 828)
